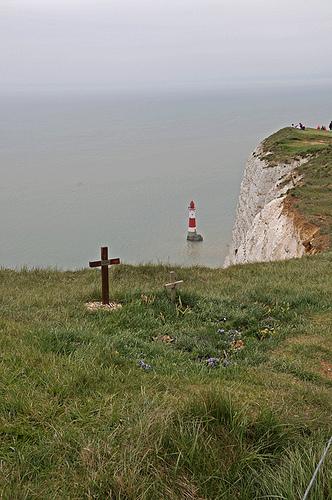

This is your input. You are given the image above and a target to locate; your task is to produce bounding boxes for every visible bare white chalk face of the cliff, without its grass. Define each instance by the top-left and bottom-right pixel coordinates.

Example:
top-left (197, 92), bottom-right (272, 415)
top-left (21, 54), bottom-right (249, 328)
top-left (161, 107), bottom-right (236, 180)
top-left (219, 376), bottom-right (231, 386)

top-left (225, 145), bottom-right (306, 267)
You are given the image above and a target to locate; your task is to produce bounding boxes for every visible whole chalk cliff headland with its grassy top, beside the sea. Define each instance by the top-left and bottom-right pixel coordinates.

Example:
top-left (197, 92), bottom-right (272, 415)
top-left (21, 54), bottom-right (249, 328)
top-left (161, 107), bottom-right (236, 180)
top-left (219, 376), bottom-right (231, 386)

top-left (224, 128), bottom-right (332, 267)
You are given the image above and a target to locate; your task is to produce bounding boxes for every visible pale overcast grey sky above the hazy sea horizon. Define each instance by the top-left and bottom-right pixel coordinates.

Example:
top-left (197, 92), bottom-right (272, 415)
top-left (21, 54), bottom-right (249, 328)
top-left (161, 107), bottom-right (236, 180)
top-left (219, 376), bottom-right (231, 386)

top-left (0, 0), bottom-right (332, 89)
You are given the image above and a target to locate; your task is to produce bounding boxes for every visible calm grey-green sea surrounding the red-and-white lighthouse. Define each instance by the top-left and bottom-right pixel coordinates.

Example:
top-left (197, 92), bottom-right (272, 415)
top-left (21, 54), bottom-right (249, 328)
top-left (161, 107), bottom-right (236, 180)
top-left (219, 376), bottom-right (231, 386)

top-left (0, 87), bottom-right (332, 269)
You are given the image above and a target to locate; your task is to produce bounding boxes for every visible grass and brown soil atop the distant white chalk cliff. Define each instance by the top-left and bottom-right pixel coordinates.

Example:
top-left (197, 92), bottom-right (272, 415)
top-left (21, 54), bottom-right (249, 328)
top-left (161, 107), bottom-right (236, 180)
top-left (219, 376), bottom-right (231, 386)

top-left (263, 128), bottom-right (332, 248)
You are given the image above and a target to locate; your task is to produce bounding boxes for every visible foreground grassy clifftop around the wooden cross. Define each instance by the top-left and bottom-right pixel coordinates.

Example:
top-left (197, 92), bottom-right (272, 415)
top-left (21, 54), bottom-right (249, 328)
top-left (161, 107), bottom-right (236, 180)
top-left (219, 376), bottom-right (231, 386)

top-left (0, 253), bottom-right (332, 500)
